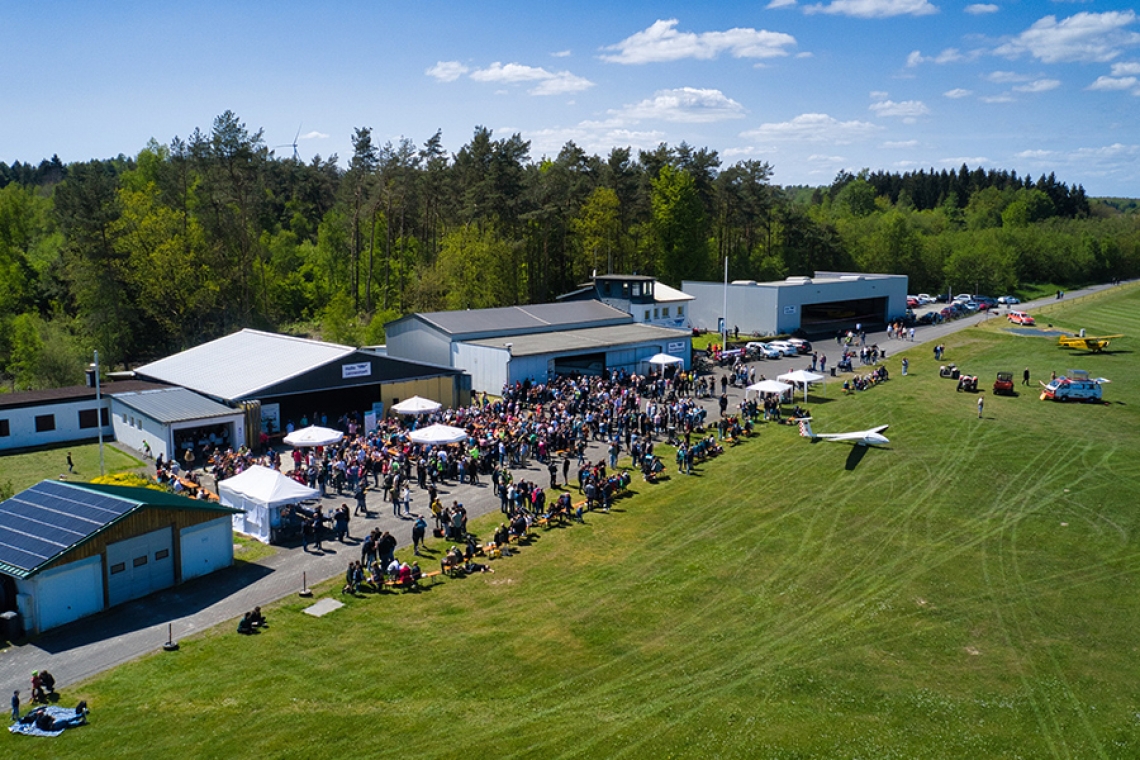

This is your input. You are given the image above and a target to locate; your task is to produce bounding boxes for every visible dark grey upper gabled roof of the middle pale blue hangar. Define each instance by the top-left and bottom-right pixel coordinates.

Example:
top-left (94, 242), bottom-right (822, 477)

top-left (415, 301), bottom-right (632, 336)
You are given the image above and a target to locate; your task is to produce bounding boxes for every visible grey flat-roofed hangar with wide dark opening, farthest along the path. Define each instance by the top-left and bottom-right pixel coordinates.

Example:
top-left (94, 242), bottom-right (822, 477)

top-left (681, 271), bottom-right (907, 336)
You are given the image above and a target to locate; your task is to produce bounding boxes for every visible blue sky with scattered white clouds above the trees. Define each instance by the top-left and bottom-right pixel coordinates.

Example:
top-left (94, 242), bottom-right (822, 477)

top-left (0, 0), bottom-right (1140, 197)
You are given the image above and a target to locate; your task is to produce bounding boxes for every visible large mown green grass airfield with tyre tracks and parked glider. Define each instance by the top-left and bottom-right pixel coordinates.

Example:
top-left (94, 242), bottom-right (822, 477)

top-left (8, 288), bottom-right (1140, 758)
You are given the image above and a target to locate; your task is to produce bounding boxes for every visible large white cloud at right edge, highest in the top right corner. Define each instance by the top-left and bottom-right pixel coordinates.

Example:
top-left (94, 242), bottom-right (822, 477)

top-left (994, 10), bottom-right (1140, 64)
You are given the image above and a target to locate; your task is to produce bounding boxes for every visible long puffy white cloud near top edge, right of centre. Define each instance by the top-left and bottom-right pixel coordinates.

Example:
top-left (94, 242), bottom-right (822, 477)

top-left (602, 18), bottom-right (796, 64)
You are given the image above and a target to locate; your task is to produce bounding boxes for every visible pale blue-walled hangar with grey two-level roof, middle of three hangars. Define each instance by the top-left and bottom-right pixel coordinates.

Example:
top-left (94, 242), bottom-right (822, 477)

top-left (384, 300), bottom-right (692, 393)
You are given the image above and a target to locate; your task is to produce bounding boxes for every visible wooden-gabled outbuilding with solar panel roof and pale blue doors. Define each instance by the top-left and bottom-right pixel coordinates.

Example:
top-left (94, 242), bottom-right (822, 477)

top-left (0, 481), bottom-right (239, 632)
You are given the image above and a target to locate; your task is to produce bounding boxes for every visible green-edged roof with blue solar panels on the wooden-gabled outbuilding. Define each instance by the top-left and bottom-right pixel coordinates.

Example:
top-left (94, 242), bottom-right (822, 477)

top-left (0, 481), bottom-right (241, 578)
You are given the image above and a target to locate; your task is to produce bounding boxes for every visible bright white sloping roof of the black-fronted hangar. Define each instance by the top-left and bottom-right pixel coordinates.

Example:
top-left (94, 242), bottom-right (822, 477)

top-left (135, 329), bottom-right (356, 400)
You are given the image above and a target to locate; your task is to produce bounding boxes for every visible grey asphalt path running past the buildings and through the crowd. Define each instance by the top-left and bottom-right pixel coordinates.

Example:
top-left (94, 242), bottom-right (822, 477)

top-left (0, 279), bottom-right (1114, 698)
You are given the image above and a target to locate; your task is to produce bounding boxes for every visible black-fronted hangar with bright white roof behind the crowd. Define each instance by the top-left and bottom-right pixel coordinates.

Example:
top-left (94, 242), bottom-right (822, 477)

top-left (133, 329), bottom-right (471, 442)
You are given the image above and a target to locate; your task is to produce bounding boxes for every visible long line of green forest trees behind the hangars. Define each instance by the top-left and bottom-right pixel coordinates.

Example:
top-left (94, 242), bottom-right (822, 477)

top-left (0, 112), bottom-right (1140, 389)
